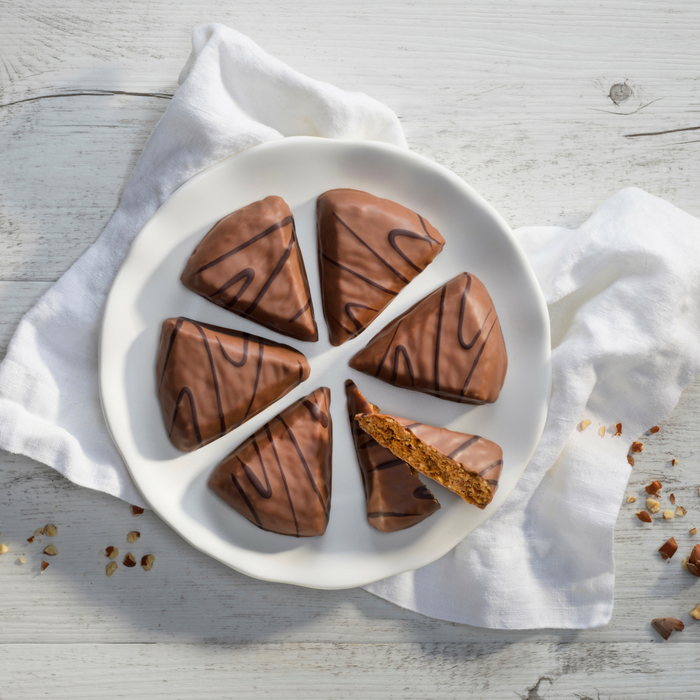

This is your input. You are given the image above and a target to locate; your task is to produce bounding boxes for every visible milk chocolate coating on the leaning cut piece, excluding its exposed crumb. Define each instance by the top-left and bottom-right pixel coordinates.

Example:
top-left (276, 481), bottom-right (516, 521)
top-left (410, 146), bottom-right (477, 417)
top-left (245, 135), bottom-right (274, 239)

top-left (360, 413), bottom-right (503, 508)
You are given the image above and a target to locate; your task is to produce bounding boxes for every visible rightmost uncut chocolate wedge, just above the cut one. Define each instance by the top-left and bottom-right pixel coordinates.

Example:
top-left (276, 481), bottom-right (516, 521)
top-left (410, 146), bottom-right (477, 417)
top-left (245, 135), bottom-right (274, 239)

top-left (350, 272), bottom-right (508, 404)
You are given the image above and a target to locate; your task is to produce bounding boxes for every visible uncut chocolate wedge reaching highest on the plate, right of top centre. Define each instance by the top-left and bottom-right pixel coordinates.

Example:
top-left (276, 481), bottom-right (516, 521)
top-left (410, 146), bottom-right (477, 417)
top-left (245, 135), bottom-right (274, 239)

top-left (316, 189), bottom-right (445, 345)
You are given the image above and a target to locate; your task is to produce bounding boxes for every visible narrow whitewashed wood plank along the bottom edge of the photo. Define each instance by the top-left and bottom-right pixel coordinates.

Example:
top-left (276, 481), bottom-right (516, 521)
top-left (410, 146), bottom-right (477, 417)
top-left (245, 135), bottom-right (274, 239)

top-left (0, 638), bottom-right (700, 700)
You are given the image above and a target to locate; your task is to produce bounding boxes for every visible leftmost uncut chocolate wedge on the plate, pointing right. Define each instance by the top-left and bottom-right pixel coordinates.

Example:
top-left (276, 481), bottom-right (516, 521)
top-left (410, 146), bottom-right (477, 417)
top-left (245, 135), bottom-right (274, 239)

top-left (156, 318), bottom-right (309, 452)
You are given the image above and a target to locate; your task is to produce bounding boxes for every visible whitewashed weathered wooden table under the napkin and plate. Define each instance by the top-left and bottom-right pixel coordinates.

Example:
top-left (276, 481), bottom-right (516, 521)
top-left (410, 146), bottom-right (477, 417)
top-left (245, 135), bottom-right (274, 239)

top-left (0, 0), bottom-right (700, 700)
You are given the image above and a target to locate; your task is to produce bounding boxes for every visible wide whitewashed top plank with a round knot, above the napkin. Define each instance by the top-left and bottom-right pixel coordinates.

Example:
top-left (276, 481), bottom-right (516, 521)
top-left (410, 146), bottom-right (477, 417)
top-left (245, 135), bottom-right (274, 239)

top-left (0, 0), bottom-right (700, 280)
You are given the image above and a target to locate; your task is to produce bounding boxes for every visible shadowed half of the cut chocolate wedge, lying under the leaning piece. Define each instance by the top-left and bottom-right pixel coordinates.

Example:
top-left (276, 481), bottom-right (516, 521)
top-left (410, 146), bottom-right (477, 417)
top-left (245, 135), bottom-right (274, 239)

top-left (345, 379), bottom-right (440, 532)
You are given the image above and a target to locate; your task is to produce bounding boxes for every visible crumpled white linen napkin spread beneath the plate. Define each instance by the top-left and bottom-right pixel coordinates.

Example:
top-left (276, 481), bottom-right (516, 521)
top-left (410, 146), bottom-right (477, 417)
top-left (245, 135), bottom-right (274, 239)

top-left (0, 25), bottom-right (700, 628)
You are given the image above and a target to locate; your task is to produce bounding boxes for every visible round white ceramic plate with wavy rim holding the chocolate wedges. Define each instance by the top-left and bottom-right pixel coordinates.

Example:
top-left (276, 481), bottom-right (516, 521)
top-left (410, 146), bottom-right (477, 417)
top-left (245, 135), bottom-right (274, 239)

top-left (100, 137), bottom-right (550, 589)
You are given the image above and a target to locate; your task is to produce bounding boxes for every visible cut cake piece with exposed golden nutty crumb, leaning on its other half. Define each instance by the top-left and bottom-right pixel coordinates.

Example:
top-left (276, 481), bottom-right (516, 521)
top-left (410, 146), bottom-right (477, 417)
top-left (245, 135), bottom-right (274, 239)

top-left (356, 413), bottom-right (503, 508)
